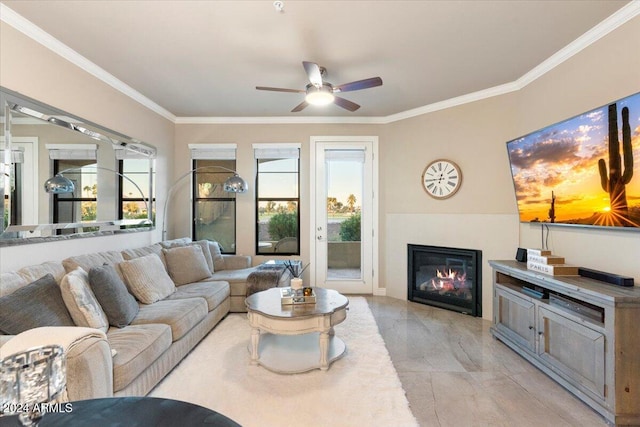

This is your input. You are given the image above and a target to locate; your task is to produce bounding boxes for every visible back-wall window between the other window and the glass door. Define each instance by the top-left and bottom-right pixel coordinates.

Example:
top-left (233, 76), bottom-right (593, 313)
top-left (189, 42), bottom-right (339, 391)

top-left (254, 144), bottom-right (300, 255)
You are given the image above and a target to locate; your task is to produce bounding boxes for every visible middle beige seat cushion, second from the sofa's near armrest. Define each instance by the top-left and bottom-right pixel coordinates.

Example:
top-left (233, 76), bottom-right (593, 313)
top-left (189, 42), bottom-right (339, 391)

top-left (131, 298), bottom-right (208, 341)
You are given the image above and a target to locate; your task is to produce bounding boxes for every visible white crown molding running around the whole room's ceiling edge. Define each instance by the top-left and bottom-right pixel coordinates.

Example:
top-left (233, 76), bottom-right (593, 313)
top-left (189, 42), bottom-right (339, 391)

top-left (0, 0), bottom-right (640, 124)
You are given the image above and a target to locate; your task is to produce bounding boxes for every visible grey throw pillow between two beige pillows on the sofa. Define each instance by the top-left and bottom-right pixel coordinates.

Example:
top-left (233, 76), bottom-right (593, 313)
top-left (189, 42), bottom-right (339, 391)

top-left (89, 264), bottom-right (140, 328)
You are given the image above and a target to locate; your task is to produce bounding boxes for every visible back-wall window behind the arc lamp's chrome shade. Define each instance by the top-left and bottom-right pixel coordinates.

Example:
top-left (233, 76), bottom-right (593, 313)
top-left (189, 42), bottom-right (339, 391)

top-left (189, 144), bottom-right (236, 254)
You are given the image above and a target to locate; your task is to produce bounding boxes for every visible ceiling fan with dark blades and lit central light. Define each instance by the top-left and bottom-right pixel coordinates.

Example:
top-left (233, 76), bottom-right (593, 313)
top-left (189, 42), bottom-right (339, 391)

top-left (256, 61), bottom-right (382, 113)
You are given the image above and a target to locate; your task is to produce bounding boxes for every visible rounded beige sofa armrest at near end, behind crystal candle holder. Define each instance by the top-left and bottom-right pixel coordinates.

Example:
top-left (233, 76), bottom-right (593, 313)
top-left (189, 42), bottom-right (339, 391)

top-left (0, 326), bottom-right (113, 401)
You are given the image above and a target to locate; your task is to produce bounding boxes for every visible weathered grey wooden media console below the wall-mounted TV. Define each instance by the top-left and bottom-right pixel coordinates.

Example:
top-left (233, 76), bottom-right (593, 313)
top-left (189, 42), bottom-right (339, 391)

top-left (489, 261), bottom-right (640, 425)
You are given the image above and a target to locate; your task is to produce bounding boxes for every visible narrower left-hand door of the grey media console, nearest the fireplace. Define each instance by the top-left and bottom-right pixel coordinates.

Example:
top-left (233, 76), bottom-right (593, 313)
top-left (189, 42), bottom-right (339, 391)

top-left (494, 284), bottom-right (536, 351)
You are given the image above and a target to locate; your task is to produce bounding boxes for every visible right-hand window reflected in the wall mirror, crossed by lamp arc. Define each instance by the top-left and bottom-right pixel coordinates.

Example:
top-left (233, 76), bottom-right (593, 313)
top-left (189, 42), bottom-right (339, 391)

top-left (116, 159), bottom-right (156, 228)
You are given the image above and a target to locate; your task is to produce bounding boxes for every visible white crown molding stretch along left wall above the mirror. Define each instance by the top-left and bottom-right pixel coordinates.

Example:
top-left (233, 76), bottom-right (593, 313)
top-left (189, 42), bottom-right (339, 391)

top-left (0, 3), bottom-right (176, 122)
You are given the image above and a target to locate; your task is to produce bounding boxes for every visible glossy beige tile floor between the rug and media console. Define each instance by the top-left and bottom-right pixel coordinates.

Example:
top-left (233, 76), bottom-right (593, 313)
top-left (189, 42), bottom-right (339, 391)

top-left (367, 296), bottom-right (607, 427)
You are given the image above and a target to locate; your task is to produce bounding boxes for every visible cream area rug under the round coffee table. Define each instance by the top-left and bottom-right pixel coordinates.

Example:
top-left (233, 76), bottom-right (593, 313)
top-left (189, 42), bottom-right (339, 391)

top-left (150, 297), bottom-right (418, 427)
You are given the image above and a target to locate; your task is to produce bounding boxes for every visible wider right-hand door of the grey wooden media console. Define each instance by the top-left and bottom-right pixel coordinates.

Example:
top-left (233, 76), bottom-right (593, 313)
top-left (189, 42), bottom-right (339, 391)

top-left (538, 307), bottom-right (605, 400)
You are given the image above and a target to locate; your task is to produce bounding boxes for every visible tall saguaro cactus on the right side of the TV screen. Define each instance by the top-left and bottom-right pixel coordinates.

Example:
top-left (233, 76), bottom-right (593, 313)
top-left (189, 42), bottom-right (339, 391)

top-left (598, 104), bottom-right (633, 218)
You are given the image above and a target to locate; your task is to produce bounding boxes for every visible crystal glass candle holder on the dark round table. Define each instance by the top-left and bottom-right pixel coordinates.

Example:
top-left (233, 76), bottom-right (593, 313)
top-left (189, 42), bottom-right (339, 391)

top-left (0, 345), bottom-right (67, 426)
